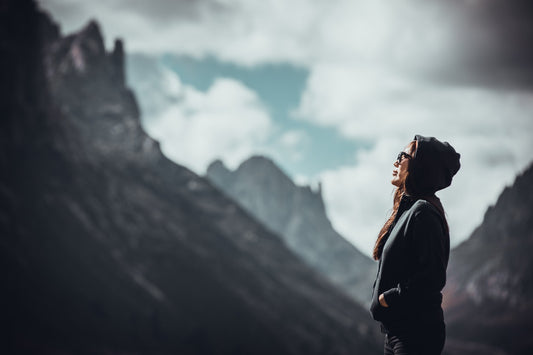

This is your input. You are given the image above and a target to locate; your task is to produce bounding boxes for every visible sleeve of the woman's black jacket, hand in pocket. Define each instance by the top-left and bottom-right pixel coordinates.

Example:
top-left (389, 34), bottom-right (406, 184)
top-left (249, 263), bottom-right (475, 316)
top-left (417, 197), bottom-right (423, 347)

top-left (384, 205), bottom-right (450, 307)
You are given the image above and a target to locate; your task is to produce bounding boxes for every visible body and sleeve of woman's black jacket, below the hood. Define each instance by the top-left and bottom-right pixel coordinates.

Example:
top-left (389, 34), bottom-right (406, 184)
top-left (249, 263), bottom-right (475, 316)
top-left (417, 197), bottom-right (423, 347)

top-left (370, 196), bottom-right (450, 332)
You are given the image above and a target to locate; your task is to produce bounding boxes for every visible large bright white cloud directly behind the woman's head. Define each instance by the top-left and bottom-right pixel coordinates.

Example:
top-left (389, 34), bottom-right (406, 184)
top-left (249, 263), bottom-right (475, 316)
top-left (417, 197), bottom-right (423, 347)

top-left (295, 65), bottom-right (533, 252)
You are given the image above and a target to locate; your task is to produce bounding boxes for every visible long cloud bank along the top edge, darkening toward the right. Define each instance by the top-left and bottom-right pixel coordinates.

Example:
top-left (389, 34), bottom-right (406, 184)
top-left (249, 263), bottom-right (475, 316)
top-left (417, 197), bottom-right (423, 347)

top-left (40, 0), bottom-right (533, 88)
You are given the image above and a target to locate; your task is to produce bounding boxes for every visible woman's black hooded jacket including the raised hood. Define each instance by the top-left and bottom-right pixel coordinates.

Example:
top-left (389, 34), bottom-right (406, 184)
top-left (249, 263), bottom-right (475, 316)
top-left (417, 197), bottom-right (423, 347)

top-left (370, 135), bottom-right (460, 333)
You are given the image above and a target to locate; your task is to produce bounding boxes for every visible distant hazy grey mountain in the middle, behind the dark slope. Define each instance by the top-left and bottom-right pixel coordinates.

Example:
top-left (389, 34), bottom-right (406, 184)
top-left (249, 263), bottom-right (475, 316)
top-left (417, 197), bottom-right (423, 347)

top-left (206, 156), bottom-right (376, 305)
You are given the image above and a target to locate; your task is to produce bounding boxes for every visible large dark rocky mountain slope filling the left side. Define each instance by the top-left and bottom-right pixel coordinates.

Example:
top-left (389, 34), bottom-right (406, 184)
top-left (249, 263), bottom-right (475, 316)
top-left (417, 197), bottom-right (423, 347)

top-left (0, 0), bottom-right (382, 354)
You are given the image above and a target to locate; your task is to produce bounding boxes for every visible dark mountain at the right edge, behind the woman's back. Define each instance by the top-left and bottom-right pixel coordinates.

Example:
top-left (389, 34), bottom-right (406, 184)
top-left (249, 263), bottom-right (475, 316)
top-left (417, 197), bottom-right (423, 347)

top-left (444, 165), bottom-right (533, 354)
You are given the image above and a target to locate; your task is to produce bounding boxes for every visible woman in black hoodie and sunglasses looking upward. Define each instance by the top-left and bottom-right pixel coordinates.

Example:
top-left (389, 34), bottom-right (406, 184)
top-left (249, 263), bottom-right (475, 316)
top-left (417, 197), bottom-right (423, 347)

top-left (370, 135), bottom-right (460, 355)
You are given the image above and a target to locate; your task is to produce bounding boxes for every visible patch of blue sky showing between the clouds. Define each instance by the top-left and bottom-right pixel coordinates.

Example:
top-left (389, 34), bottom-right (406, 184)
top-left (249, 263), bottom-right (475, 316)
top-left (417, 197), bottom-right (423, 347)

top-left (160, 54), bottom-right (369, 177)
